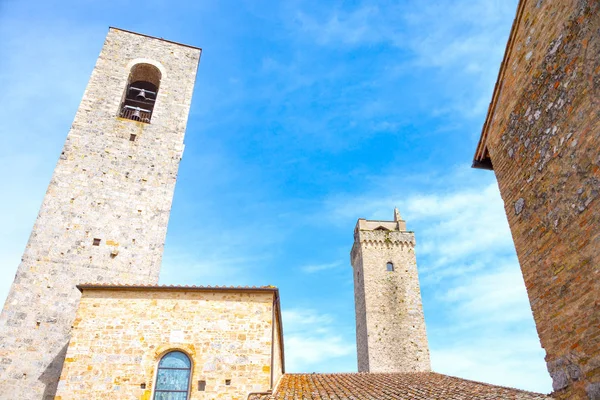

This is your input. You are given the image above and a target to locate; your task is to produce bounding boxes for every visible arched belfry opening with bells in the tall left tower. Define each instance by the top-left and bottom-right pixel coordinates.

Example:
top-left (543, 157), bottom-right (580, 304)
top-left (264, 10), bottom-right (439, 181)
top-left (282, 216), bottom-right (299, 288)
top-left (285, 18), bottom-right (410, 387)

top-left (119, 64), bottom-right (162, 123)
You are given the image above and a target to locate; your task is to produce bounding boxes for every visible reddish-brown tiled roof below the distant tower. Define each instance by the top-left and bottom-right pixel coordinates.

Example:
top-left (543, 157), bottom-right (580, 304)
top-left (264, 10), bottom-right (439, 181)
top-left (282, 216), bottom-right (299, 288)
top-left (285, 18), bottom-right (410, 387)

top-left (255, 372), bottom-right (551, 400)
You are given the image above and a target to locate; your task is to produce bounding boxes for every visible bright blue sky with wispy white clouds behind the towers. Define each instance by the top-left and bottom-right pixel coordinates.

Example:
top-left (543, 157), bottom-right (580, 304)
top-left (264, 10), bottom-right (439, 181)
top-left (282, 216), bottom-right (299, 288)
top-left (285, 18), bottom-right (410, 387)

top-left (0, 0), bottom-right (551, 392)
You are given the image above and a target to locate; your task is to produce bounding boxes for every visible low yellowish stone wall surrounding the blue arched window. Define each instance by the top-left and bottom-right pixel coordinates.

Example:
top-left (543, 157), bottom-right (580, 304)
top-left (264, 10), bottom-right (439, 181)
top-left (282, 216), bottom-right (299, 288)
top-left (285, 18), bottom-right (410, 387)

top-left (56, 289), bottom-right (281, 400)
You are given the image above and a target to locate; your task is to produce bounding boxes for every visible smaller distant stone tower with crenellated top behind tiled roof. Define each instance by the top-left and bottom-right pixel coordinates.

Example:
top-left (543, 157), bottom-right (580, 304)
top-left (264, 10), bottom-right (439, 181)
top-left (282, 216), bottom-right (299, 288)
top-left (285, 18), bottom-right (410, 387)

top-left (350, 209), bottom-right (431, 372)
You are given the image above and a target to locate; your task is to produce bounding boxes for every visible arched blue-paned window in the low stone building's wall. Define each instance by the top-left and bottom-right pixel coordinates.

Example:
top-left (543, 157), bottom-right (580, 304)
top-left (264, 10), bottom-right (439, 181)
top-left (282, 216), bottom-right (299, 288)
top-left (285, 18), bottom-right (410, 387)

top-left (154, 351), bottom-right (192, 400)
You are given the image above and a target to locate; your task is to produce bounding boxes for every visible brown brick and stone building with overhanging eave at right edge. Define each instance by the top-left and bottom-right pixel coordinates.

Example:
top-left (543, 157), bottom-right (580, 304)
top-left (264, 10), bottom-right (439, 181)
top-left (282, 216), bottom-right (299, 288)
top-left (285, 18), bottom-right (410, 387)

top-left (474, 0), bottom-right (600, 399)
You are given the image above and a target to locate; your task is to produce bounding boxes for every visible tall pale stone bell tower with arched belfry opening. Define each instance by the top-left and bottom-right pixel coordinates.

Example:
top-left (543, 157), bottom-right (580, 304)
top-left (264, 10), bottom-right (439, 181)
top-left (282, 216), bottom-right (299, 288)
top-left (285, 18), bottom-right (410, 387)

top-left (0, 28), bottom-right (201, 400)
